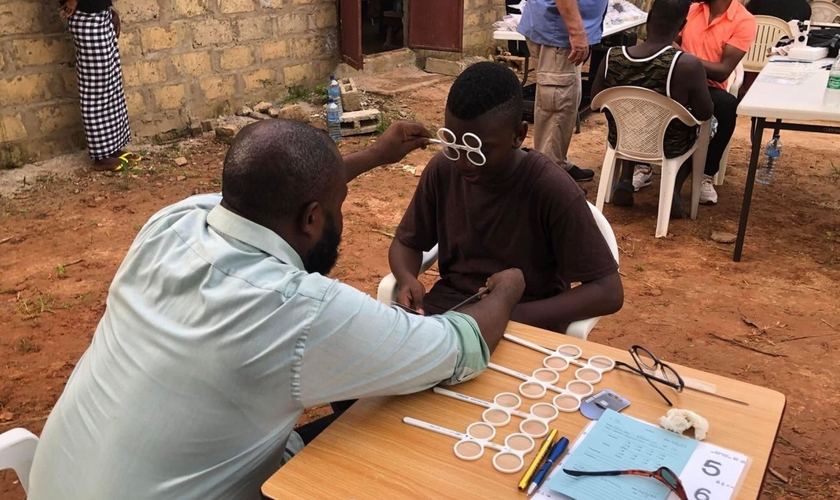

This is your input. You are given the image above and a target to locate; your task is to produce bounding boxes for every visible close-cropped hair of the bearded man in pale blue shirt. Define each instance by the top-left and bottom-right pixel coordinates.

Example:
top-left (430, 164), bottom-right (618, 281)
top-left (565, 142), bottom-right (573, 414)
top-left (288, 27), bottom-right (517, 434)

top-left (222, 120), bottom-right (341, 221)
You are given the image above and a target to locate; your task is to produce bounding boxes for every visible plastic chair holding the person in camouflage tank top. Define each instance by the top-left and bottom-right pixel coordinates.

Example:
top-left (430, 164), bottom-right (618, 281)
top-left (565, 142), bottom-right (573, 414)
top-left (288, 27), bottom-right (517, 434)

top-left (592, 86), bottom-right (710, 238)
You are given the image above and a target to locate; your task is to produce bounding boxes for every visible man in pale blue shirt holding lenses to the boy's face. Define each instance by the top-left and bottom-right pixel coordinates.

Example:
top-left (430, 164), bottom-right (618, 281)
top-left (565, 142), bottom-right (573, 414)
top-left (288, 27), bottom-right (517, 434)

top-left (29, 120), bottom-right (525, 500)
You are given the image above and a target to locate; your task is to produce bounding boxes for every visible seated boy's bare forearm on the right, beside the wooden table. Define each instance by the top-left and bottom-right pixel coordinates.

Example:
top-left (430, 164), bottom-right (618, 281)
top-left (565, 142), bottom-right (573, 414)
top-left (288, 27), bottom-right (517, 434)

top-left (510, 271), bottom-right (624, 329)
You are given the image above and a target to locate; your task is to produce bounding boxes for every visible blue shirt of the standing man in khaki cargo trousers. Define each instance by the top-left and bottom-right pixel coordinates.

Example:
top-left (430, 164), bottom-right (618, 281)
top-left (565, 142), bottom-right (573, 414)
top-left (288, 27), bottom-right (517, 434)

top-left (518, 0), bottom-right (608, 49)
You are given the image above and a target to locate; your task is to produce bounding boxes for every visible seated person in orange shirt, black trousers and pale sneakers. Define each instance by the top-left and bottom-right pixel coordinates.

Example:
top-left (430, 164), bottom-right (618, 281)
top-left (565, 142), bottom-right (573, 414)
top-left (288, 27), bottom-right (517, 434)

top-left (633, 0), bottom-right (758, 204)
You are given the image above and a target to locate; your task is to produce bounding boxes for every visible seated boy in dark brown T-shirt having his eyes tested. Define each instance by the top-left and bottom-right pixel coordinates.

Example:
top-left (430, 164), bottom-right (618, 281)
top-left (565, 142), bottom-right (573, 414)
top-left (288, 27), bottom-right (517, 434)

top-left (389, 62), bottom-right (624, 332)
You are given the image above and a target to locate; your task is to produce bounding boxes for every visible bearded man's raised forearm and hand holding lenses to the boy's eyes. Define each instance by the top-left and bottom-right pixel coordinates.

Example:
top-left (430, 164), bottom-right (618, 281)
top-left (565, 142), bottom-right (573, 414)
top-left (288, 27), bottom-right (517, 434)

top-left (344, 122), bottom-right (432, 182)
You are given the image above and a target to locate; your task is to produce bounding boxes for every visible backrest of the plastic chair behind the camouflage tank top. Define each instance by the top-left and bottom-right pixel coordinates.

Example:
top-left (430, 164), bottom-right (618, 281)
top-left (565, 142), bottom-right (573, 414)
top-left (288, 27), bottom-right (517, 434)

top-left (592, 87), bottom-right (700, 163)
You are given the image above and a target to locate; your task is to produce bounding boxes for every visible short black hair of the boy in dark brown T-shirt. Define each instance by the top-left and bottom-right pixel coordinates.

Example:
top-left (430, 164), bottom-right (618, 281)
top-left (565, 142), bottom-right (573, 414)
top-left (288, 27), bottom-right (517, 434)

top-left (446, 61), bottom-right (524, 126)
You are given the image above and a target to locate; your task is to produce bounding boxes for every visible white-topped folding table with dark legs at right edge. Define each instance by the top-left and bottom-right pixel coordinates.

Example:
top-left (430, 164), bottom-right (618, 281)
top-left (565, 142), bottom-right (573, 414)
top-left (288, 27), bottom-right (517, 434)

top-left (733, 59), bottom-right (840, 262)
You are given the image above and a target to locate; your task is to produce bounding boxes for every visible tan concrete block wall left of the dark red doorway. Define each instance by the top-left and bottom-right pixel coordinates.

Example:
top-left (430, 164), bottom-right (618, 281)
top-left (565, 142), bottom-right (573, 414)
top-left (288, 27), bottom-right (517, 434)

top-left (0, 0), bottom-right (338, 168)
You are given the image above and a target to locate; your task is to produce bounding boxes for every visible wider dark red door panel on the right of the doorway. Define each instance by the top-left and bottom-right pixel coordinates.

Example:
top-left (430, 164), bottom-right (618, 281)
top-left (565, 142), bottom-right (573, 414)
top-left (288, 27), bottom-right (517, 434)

top-left (408, 0), bottom-right (464, 52)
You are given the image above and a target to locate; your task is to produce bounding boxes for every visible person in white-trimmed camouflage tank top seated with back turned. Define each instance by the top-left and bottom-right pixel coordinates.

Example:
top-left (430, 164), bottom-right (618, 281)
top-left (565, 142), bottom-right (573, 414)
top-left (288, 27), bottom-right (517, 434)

top-left (592, 0), bottom-right (712, 218)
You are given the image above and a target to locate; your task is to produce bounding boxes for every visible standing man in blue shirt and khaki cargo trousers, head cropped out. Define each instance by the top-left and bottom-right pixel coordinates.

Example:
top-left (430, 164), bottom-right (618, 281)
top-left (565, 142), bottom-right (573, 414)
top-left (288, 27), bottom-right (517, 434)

top-left (519, 0), bottom-right (608, 182)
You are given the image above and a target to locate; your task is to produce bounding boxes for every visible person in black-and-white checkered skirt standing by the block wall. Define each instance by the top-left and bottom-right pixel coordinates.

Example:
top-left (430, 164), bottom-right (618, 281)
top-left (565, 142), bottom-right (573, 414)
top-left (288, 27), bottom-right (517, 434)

top-left (61, 0), bottom-right (131, 170)
